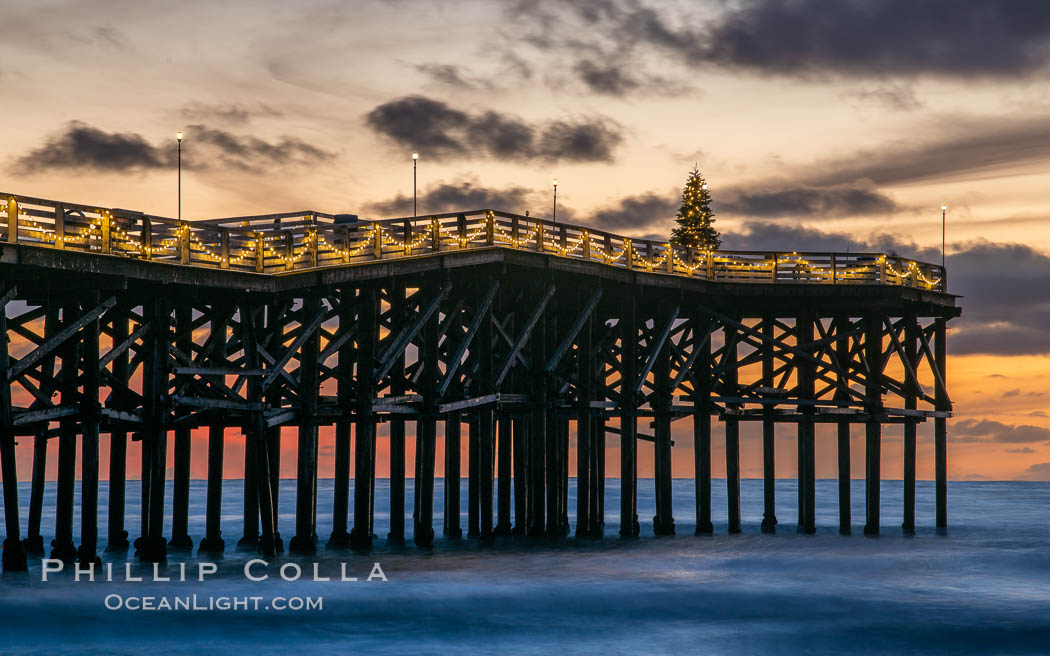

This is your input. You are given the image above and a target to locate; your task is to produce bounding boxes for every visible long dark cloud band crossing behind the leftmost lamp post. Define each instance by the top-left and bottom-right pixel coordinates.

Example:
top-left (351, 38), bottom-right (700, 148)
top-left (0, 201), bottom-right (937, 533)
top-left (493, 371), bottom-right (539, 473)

top-left (14, 121), bottom-right (333, 174)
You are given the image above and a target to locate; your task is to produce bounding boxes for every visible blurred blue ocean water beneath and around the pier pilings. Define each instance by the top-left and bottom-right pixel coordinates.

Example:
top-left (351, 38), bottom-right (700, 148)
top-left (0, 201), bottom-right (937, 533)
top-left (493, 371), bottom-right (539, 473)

top-left (0, 480), bottom-right (1050, 655)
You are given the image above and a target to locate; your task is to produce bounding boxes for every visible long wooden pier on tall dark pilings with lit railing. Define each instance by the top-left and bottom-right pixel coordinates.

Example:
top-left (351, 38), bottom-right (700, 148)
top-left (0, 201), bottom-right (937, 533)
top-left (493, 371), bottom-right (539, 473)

top-left (0, 194), bottom-right (959, 570)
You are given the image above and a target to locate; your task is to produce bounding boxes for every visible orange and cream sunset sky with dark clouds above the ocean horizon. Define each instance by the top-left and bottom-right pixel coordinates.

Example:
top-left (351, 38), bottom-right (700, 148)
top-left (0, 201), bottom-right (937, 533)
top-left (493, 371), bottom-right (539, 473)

top-left (0, 0), bottom-right (1050, 480)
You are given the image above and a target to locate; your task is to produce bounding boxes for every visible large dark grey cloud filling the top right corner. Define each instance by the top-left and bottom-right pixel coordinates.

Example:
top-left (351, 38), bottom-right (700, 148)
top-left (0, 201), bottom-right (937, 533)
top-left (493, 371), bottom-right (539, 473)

top-left (529, 0), bottom-right (1050, 78)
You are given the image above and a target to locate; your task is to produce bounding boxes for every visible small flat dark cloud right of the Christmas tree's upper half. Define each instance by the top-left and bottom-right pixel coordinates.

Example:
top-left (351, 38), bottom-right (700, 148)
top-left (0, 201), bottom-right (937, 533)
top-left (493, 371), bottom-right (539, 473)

top-left (717, 186), bottom-right (900, 218)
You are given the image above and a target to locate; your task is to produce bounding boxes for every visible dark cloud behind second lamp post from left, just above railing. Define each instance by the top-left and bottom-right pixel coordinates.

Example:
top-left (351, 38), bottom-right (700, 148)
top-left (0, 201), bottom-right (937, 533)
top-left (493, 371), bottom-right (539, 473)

top-left (365, 178), bottom-right (541, 217)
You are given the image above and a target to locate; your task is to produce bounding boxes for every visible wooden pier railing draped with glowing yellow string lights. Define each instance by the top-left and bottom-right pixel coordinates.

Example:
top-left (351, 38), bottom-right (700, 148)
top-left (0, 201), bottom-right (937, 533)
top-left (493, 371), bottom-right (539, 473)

top-left (0, 194), bottom-right (947, 292)
